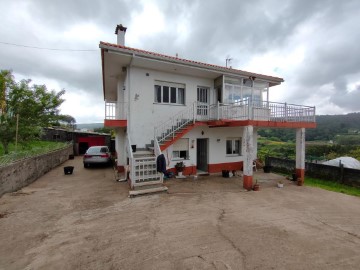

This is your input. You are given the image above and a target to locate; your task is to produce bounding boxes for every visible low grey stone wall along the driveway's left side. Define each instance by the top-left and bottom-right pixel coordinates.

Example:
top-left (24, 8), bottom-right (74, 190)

top-left (0, 145), bottom-right (73, 197)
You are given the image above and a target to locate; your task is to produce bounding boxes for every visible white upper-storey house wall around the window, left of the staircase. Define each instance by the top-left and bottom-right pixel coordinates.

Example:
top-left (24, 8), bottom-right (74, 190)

top-left (126, 67), bottom-right (214, 148)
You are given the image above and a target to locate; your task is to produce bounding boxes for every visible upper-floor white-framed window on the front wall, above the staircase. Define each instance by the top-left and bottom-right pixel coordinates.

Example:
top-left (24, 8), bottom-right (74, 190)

top-left (154, 81), bottom-right (185, 105)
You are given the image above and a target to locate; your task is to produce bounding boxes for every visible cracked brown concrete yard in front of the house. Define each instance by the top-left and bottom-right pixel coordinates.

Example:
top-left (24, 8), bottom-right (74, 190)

top-left (0, 158), bottom-right (360, 269)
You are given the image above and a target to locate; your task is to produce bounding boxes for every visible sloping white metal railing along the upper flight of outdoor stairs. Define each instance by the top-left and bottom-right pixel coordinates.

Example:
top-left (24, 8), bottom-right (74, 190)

top-left (154, 101), bottom-right (197, 143)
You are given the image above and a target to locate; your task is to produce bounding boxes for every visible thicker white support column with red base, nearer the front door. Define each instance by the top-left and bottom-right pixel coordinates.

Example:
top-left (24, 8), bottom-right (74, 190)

top-left (243, 126), bottom-right (254, 190)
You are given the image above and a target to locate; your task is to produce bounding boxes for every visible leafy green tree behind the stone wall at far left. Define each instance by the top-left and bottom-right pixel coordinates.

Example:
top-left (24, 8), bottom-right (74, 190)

top-left (0, 70), bottom-right (65, 154)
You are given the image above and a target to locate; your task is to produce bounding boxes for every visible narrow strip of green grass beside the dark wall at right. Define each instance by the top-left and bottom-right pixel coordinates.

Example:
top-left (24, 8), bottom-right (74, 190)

top-left (304, 177), bottom-right (360, 197)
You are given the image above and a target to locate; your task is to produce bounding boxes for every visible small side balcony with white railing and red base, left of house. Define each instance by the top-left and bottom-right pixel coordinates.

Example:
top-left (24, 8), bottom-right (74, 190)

top-left (104, 101), bottom-right (128, 127)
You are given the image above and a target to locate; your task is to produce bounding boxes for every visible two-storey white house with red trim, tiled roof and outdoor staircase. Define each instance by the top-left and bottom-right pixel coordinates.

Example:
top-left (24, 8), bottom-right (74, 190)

top-left (99, 25), bottom-right (316, 189)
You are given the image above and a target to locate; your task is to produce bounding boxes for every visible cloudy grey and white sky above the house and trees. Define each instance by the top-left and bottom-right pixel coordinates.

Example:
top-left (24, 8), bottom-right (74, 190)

top-left (0, 0), bottom-right (360, 123)
